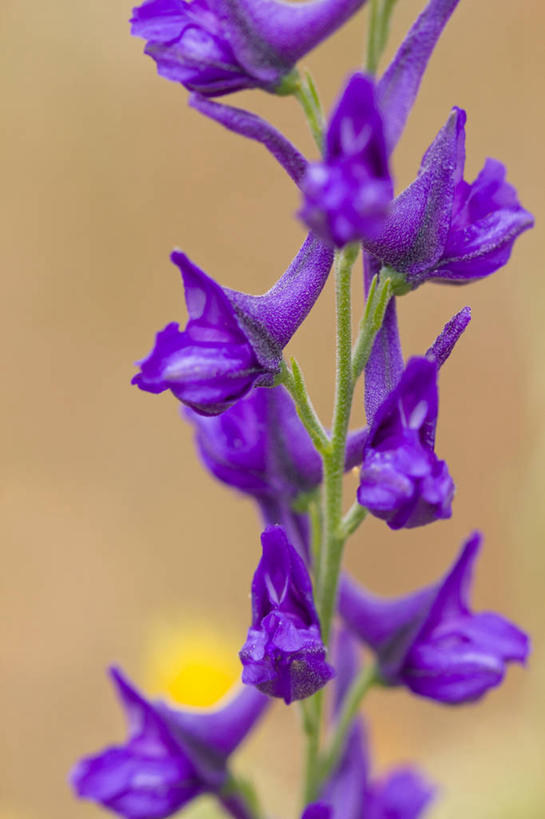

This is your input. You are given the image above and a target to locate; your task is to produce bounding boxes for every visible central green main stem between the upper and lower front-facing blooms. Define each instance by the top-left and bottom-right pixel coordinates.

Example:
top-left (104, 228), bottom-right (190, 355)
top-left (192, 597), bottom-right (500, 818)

top-left (320, 245), bottom-right (359, 645)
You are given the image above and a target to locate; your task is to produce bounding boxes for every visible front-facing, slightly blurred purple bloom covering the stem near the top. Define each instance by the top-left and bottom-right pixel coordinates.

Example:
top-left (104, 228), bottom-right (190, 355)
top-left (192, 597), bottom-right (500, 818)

top-left (299, 74), bottom-right (392, 247)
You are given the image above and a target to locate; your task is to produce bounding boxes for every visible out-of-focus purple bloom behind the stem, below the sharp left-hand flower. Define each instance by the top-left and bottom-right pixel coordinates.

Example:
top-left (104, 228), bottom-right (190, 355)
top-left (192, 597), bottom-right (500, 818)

top-left (184, 386), bottom-right (368, 560)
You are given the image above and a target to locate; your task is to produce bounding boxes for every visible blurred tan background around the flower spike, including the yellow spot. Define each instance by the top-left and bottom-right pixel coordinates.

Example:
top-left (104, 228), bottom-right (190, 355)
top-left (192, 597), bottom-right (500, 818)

top-left (0, 0), bottom-right (545, 819)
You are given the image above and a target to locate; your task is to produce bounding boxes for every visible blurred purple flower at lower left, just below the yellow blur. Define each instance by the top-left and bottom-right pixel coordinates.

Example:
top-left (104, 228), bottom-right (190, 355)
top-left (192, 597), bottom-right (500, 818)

top-left (71, 669), bottom-right (268, 819)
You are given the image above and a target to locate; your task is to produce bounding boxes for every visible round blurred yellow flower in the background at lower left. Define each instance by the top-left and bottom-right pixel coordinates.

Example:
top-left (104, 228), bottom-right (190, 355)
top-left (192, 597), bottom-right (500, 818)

top-left (144, 621), bottom-right (241, 708)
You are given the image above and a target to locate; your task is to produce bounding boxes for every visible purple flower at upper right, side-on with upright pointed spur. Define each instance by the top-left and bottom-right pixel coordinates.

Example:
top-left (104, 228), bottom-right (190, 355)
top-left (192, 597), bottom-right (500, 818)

top-left (366, 108), bottom-right (534, 289)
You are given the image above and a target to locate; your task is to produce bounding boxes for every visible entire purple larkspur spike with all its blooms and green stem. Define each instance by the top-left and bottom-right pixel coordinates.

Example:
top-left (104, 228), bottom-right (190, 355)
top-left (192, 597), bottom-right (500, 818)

top-left (71, 0), bottom-right (533, 819)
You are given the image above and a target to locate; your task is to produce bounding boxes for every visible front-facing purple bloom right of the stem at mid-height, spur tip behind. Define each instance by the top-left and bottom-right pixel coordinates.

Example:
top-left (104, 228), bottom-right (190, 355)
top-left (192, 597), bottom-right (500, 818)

top-left (358, 307), bottom-right (471, 529)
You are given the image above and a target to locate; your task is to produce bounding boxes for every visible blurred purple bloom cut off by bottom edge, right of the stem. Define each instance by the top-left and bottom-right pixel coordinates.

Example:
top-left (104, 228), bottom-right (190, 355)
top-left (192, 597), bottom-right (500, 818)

top-left (302, 630), bottom-right (434, 819)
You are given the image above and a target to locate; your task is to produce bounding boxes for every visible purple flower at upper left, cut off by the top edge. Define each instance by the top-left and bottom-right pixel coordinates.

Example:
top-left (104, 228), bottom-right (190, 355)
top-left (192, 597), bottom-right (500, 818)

top-left (131, 0), bottom-right (365, 96)
